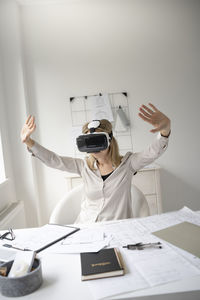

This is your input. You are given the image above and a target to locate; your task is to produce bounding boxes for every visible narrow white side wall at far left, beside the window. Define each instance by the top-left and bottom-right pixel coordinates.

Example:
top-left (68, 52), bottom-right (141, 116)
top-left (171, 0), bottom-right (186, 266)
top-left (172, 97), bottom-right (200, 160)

top-left (0, 0), bottom-right (38, 226)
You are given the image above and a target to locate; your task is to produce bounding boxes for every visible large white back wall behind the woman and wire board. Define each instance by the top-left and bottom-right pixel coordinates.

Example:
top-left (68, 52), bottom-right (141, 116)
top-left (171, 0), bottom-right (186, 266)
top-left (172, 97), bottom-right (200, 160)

top-left (3, 0), bottom-right (200, 222)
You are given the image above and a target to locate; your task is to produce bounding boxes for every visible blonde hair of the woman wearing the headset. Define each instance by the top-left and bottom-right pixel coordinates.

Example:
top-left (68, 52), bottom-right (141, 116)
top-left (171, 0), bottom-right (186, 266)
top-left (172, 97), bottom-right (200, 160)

top-left (82, 119), bottom-right (123, 170)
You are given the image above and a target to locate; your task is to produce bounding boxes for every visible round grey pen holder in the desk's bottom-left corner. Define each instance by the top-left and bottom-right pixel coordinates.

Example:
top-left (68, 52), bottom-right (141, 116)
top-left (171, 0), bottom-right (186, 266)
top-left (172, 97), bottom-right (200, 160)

top-left (0, 259), bottom-right (42, 297)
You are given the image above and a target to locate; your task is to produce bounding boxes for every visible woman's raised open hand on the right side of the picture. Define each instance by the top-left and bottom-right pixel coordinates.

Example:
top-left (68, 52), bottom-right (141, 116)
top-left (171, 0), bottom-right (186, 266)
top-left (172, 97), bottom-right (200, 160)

top-left (139, 103), bottom-right (170, 133)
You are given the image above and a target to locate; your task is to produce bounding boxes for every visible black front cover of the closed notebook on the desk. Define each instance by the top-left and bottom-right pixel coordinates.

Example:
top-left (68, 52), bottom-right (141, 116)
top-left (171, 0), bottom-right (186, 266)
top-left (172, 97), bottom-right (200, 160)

top-left (80, 248), bottom-right (123, 276)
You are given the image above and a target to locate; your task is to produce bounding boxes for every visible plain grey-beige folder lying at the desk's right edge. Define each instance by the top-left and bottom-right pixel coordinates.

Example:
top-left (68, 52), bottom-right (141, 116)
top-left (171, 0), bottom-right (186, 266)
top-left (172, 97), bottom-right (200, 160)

top-left (152, 222), bottom-right (200, 258)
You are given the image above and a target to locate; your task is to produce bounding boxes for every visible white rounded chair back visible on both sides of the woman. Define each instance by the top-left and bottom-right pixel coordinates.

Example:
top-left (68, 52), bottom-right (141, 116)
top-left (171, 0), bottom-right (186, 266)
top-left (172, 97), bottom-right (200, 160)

top-left (49, 184), bottom-right (150, 224)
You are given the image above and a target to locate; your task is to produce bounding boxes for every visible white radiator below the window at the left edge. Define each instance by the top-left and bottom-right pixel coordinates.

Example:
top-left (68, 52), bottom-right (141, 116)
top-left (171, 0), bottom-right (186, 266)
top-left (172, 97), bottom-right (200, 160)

top-left (0, 202), bottom-right (26, 230)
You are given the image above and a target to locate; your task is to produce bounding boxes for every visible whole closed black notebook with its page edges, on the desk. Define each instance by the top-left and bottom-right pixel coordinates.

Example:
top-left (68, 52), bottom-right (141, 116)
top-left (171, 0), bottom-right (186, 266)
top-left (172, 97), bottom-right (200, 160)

top-left (80, 248), bottom-right (124, 280)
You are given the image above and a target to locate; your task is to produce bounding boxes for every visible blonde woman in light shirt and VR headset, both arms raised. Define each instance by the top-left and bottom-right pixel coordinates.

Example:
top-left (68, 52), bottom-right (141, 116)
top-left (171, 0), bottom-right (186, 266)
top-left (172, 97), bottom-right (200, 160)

top-left (21, 103), bottom-right (171, 223)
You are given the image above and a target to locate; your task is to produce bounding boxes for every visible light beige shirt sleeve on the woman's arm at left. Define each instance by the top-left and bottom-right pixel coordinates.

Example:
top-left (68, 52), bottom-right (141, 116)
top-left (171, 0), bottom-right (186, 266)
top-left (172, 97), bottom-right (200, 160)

top-left (28, 142), bottom-right (84, 175)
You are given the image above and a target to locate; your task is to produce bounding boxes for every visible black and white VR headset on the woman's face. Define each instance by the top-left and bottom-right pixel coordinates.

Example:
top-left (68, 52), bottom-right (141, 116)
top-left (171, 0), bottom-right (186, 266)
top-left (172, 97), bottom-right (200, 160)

top-left (76, 120), bottom-right (112, 153)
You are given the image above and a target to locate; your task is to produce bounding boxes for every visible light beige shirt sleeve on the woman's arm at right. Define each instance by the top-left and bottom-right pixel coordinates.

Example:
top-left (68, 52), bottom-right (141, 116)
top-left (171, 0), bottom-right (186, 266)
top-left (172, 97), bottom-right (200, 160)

top-left (131, 133), bottom-right (169, 171)
